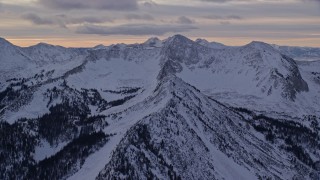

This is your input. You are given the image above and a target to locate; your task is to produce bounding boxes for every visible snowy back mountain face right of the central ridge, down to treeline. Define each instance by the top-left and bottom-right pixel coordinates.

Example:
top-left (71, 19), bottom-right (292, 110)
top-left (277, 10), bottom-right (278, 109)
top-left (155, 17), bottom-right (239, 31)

top-left (158, 35), bottom-right (312, 116)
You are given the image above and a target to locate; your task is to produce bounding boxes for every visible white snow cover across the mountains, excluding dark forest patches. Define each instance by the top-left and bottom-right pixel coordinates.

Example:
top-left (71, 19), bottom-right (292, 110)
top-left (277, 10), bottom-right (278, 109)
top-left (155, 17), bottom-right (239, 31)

top-left (0, 35), bottom-right (320, 180)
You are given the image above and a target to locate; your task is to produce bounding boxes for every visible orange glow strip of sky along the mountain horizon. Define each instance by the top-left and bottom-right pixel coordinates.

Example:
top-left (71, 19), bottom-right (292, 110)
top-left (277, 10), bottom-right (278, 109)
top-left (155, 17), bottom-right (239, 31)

top-left (5, 36), bottom-right (320, 48)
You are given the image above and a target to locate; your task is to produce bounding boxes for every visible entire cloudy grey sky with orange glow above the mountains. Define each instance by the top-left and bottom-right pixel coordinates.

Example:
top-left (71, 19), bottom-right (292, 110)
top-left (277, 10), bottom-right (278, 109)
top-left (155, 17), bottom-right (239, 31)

top-left (0, 0), bottom-right (320, 47)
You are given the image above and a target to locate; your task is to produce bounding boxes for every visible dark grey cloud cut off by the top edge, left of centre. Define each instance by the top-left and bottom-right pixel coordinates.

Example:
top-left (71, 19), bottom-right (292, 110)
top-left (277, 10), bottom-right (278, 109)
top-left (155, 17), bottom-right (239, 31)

top-left (38, 0), bottom-right (138, 11)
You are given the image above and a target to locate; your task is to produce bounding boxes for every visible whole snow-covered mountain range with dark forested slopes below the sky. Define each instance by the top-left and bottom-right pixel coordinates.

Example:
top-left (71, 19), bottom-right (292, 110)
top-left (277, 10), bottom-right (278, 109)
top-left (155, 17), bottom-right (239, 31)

top-left (0, 35), bottom-right (320, 180)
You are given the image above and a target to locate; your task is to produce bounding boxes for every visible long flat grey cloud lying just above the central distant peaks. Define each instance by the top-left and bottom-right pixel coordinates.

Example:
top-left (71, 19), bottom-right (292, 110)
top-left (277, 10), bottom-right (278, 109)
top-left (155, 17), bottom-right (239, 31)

top-left (76, 24), bottom-right (197, 36)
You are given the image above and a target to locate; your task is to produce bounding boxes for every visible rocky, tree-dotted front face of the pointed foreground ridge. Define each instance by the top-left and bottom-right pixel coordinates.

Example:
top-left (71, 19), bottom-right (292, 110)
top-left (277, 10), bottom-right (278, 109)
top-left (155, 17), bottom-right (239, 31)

top-left (97, 77), bottom-right (316, 179)
